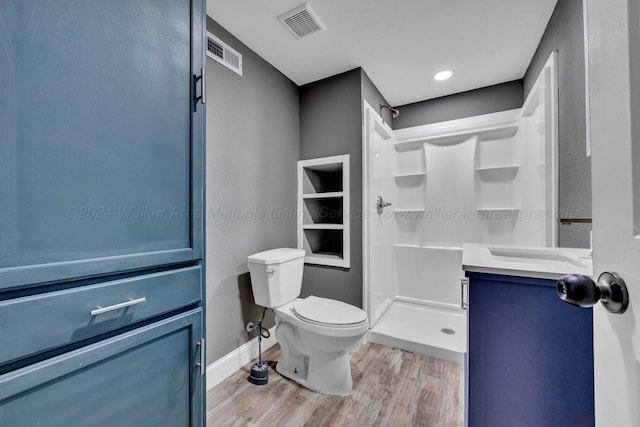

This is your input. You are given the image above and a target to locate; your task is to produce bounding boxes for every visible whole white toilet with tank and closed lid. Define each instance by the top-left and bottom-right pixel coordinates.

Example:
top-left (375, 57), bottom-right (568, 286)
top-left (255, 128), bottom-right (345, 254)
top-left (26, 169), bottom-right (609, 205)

top-left (248, 248), bottom-right (369, 395)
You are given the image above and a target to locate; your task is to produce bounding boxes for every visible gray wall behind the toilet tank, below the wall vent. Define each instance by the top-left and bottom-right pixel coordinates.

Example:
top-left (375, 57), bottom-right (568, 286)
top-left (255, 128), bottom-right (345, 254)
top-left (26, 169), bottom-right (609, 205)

top-left (206, 18), bottom-right (300, 363)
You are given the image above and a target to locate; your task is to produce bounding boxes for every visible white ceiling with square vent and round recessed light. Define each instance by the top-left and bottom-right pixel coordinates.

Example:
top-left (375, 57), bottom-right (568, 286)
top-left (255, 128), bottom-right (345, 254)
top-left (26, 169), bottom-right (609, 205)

top-left (207, 0), bottom-right (557, 106)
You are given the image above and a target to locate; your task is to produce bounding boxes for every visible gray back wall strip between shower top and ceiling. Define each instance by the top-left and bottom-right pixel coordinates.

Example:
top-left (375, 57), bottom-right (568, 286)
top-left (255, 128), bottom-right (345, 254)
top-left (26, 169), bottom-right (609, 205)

top-left (393, 80), bottom-right (523, 129)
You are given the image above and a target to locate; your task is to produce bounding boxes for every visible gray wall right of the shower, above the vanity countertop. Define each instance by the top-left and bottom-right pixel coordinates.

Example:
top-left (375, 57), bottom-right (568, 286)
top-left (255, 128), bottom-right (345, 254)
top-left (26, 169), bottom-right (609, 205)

top-left (524, 0), bottom-right (591, 247)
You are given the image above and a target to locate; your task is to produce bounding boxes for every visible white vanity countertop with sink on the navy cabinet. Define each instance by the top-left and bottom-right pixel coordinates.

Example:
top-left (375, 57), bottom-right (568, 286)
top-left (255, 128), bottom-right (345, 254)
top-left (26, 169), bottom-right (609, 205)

top-left (462, 243), bottom-right (593, 280)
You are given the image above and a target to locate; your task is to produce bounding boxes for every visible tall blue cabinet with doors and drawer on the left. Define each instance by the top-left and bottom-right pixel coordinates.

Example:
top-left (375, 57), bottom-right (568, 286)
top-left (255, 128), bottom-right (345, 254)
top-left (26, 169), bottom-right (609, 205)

top-left (0, 0), bottom-right (206, 427)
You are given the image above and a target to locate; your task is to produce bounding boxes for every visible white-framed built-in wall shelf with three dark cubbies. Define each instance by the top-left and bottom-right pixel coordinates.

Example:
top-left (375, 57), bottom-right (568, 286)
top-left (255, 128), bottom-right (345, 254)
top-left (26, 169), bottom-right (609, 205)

top-left (297, 154), bottom-right (350, 268)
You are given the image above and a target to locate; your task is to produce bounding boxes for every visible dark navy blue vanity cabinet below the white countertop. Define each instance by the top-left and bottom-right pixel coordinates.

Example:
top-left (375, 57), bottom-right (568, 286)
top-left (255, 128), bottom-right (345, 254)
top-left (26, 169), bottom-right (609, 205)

top-left (467, 272), bottom-right (594, 427)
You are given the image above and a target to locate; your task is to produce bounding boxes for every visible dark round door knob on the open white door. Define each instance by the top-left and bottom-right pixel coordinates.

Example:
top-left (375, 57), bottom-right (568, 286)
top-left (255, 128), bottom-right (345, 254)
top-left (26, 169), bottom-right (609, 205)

top-left (556, 271), bottom-right (629, 314)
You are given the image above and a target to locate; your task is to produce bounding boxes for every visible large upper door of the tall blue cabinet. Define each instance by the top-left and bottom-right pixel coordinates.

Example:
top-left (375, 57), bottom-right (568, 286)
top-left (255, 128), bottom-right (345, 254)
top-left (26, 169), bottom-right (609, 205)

top-left (0, 0), bottom-right (205, 292)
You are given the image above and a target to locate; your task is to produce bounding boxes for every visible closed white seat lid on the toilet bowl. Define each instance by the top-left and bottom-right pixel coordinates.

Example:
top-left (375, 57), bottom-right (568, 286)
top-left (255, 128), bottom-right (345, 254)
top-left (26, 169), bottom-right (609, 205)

top-left (291, 296), bottom-right (367, 328)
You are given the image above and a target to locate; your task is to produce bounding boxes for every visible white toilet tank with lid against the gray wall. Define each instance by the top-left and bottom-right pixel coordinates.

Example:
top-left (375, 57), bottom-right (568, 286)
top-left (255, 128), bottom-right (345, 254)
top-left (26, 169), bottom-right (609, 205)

top-left (247, 248), bottom-right (305, 307)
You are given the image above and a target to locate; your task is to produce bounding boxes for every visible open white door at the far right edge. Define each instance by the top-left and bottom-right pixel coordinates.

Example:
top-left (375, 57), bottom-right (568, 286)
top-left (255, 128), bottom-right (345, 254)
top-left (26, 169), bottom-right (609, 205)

top-left (586, 0), bottom-right (640, 427)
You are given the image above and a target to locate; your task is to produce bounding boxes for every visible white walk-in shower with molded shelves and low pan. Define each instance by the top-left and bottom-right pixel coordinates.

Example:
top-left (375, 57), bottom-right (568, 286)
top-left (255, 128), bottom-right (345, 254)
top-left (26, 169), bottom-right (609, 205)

top-left (363, 56), bottom-right (557, 363)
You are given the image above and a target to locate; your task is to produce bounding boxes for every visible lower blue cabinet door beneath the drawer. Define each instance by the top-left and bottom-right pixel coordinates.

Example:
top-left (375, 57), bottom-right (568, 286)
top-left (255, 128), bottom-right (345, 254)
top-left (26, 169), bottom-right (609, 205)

top-left (0, 309), bottom-right (204, 427)
